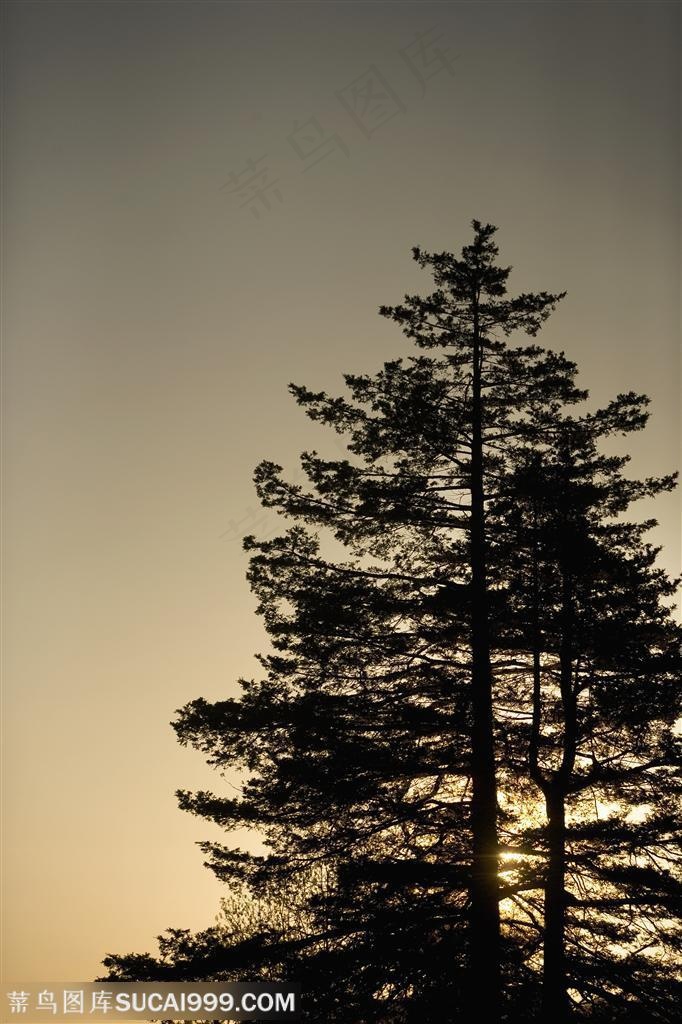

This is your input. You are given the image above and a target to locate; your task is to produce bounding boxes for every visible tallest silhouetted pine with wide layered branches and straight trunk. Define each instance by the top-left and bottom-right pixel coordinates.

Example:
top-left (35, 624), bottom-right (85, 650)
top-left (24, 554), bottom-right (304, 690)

top-left (99, 221), bottom-right (668, 1024)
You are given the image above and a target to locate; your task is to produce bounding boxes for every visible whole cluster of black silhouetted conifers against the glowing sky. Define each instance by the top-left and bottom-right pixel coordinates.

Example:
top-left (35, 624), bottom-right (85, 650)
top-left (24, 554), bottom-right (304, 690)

top-left (98, 221), bottom-right (682, 1024)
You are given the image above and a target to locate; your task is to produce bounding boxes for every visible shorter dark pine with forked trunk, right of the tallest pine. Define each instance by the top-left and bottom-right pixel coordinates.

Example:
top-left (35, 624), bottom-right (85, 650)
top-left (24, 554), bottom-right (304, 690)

top-left (491, 403), bottom-right (682, 1022)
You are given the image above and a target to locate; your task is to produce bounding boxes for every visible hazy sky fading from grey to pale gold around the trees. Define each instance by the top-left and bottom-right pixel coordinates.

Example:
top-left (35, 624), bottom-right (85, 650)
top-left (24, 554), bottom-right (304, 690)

top-left (2, 0), bottom-right (680, 981)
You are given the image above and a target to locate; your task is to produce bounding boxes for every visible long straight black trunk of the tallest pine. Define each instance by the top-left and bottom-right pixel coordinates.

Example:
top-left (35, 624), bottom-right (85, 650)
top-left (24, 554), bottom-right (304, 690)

top-left (470, 298), bottom-right (501, 1024)
